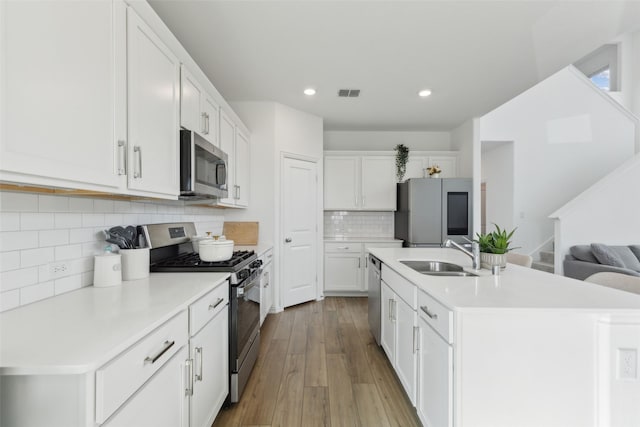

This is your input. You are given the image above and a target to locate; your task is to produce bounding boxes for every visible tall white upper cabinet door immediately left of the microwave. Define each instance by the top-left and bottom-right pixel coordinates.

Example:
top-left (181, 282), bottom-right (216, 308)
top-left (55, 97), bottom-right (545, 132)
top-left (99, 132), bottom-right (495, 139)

top-left (127, 8), bottom-right (180, 197)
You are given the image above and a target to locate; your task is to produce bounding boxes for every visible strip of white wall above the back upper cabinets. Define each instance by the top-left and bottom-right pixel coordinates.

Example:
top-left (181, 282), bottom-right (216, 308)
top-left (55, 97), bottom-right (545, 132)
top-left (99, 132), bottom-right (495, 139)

top-left (324, 131), bottom-right (452, 151)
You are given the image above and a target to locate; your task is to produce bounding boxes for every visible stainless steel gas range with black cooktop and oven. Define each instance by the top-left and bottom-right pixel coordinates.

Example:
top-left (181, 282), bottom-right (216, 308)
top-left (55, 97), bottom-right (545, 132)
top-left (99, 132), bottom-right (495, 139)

top-left (142, 223), bottom-right (262, 403)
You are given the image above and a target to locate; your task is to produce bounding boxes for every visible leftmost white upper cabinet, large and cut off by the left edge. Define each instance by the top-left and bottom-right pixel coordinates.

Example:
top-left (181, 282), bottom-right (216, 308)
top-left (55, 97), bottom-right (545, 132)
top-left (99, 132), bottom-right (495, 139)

top-left (0, 1), bottom-right (126, 191)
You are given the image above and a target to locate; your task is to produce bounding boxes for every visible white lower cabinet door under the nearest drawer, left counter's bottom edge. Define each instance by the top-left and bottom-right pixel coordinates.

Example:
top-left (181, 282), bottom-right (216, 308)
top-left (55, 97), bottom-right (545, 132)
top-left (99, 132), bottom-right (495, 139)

top-left (102, 346), bottom-right (189, 427)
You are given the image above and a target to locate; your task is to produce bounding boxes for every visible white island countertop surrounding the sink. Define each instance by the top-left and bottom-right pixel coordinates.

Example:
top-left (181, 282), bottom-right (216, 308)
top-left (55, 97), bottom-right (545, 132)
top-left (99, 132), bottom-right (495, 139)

top-left (371, 248), bottom-right (640, 314)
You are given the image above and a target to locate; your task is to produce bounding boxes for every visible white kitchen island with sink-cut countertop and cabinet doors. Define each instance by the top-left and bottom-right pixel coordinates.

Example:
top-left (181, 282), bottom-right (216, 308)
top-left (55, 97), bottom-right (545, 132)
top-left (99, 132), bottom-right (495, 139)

top-left (371, 248), bottom-right (640, 427)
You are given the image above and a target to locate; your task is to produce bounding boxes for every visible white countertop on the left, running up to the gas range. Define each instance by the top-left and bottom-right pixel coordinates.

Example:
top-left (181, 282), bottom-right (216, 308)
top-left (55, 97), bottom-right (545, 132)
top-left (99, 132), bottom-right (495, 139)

top-left (0, 273), bottom-right (229, 375)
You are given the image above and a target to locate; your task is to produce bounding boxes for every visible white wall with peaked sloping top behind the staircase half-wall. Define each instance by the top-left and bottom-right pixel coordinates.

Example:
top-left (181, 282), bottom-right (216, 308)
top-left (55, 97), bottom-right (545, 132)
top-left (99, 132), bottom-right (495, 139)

top-left (479, 67), bottom-right (635, 253)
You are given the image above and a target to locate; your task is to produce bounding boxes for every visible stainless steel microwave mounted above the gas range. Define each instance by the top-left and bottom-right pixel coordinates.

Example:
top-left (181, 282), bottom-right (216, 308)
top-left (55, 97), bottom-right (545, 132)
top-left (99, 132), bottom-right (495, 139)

top-left (180, 129), bottom-right (228, 200)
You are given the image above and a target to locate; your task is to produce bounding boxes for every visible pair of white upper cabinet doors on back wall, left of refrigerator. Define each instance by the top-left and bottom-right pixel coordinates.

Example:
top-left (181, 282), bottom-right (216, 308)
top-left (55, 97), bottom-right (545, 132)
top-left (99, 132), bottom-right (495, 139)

top-left (324, 155), bottom-right (396, 211)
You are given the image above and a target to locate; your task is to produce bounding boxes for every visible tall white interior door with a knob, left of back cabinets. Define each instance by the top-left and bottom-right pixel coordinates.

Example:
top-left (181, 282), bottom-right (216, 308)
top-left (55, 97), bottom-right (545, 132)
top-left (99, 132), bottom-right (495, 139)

top-left (282, 158), bottom-right (318, 307)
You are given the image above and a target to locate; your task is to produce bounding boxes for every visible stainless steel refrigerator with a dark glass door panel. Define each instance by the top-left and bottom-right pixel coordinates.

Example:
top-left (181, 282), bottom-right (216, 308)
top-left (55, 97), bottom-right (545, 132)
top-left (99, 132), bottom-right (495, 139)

top-left (394, 178), bottom-right (473, 247)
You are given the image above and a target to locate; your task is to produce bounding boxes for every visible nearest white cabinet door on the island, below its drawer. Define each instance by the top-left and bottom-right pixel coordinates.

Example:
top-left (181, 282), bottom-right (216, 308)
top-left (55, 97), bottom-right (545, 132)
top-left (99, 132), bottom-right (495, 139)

top-left (416, 314), bottom-right (453, 427)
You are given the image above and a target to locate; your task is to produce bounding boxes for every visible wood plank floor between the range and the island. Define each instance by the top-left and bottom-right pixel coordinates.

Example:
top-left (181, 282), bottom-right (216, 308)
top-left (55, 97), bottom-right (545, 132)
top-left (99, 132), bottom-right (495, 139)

top-left (213, 297), bottom-right (420, 427)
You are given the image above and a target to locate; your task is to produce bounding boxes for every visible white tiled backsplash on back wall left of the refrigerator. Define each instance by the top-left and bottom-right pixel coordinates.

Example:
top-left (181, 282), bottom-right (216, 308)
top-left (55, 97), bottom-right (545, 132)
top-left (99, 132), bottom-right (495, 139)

top-left (324, 211), bottom-right (393, 237)
